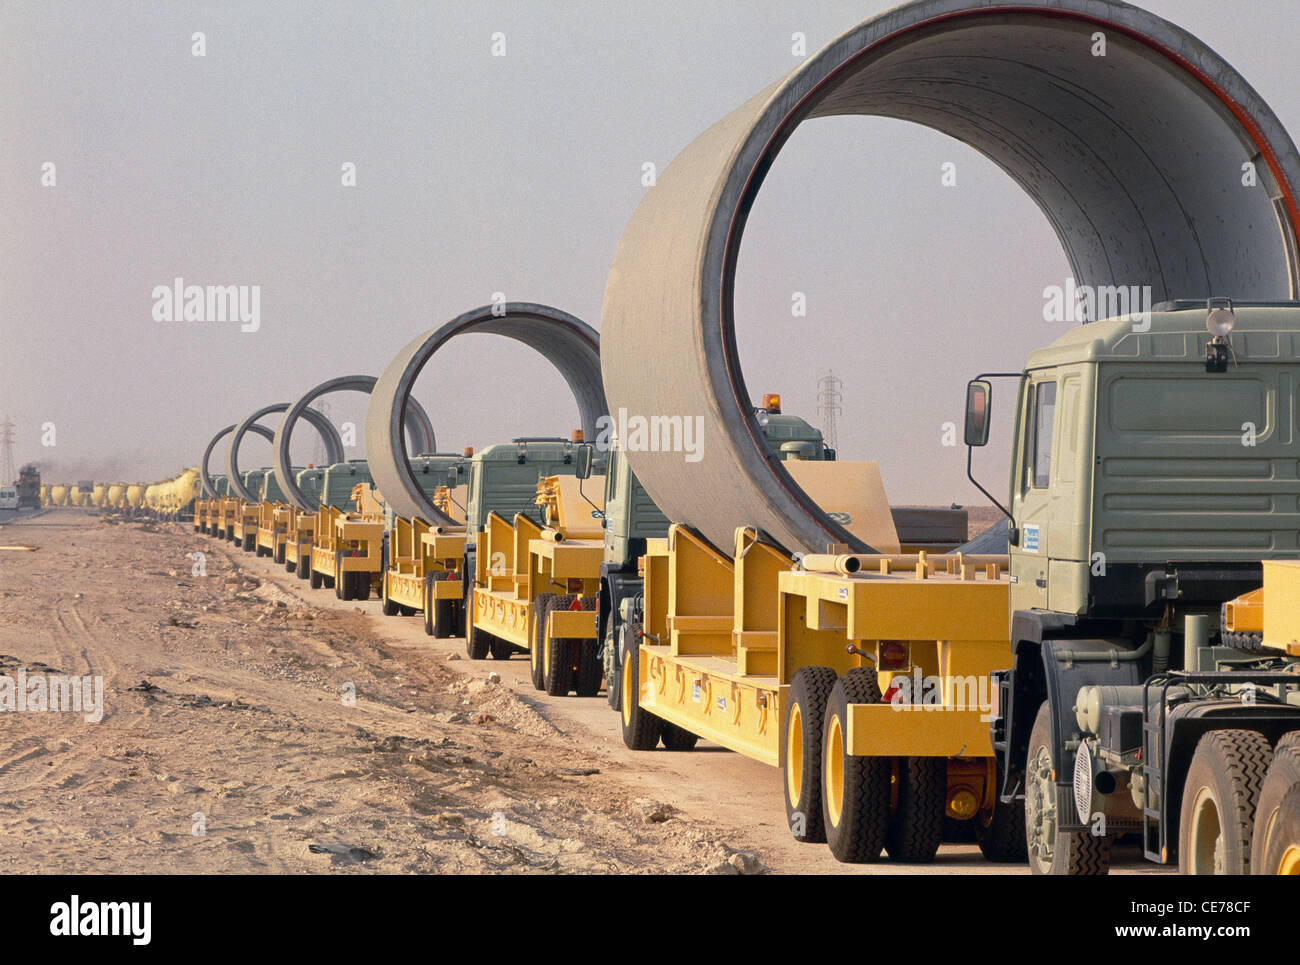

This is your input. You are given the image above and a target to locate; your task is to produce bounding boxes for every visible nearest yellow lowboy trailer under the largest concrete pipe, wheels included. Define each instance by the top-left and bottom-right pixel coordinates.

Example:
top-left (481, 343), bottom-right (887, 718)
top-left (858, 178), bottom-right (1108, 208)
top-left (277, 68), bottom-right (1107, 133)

top-left (620, 515), bottom-right (1024, 861)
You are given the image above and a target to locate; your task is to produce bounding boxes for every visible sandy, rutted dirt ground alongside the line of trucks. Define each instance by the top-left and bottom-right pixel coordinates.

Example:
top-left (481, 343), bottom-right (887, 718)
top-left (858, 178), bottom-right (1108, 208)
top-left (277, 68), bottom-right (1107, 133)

top-left (0, 510), bottom-right (1156, 874)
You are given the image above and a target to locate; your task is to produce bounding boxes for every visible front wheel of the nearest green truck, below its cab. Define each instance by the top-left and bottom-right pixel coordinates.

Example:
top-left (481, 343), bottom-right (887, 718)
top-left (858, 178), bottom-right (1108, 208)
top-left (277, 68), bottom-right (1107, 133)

top-left (1024, 701), bottom-right (1110, 875)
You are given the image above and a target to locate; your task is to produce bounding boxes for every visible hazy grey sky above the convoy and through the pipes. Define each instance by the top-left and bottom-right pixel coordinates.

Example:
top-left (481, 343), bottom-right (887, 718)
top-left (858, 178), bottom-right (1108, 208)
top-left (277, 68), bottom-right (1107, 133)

top-left (0, 0), bottom-right (1300, 503)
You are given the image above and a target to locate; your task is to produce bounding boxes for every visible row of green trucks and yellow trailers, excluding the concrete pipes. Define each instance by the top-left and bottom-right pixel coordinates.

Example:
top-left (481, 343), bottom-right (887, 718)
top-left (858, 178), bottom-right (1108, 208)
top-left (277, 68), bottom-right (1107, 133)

top-left (172, 302), bottom-right (1300, 874)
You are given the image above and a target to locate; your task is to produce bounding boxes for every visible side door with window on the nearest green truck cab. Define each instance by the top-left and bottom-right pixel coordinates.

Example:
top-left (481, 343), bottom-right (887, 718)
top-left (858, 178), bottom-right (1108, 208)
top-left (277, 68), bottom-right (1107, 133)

top-left (1010, 372), bottom-right (1057, 611)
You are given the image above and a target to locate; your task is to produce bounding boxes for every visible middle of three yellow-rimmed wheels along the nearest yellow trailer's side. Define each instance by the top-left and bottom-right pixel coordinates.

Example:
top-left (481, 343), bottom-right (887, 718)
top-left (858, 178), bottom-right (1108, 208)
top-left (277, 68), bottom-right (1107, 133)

top-left (781, 667), bottom-right (836, 843)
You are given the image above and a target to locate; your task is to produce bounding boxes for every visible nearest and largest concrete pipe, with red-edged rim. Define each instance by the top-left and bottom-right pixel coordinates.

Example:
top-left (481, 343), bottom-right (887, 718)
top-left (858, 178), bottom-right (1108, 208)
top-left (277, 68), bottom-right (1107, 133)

top-left (601, 0), bottom-right (1300, 553)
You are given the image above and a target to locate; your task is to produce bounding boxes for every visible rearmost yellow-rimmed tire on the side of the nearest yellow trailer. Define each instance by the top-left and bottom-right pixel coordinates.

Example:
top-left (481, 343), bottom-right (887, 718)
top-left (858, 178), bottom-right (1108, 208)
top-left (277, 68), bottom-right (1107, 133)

top-left (822, 667), bottom-right (893, 864)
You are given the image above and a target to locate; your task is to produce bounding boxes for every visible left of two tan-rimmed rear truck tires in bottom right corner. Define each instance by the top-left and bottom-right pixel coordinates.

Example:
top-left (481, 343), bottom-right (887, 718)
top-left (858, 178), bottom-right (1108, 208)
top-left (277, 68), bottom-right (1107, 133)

top-left (1178, 730), bottom-right (1273, 874)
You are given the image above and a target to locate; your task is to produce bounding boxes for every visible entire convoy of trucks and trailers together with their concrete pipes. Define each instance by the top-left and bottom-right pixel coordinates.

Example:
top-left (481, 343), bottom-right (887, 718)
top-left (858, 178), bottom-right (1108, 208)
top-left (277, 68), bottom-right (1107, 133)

top-left (22, 0), bottom-right (1300, 875)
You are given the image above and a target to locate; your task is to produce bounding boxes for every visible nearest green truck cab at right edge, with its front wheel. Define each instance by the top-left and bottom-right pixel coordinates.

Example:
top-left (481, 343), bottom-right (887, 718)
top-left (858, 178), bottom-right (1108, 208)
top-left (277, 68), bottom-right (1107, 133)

top-left (966, 299), bottom-right (1300, 874)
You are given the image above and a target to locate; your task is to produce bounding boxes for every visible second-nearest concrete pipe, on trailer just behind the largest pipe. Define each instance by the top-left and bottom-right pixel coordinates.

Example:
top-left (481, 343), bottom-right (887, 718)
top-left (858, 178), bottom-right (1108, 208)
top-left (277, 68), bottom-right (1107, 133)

top-left (365, 302), bottom-right (608, 523)
